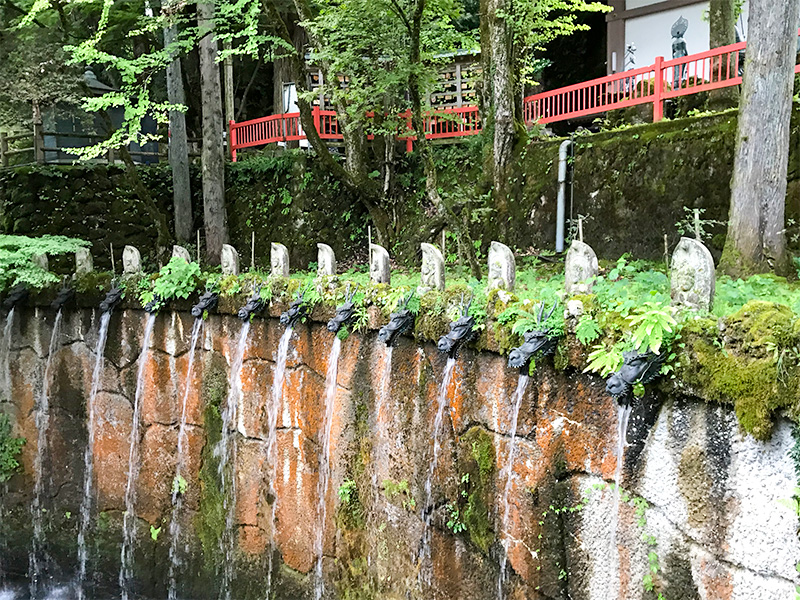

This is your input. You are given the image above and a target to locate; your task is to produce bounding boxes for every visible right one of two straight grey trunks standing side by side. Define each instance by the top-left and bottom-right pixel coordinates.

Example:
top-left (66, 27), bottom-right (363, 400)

top-left (197, 2), bottom-right (228, 265)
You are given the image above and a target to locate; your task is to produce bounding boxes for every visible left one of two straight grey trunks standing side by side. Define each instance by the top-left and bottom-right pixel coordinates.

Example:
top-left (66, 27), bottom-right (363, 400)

top-left (164, 25), bottom-right (192, 242)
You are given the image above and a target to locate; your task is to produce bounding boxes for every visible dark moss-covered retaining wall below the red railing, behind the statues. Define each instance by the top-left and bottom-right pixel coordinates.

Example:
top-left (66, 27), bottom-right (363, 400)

top-left (0, 111), bottom-right (800, 268)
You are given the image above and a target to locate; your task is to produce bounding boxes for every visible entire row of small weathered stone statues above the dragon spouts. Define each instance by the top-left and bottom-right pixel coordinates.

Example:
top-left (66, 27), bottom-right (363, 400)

top-left (62, 232), bottom-right (715, 310)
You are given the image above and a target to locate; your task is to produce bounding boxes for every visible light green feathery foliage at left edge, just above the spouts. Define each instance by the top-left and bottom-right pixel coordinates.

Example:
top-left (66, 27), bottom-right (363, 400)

top-left (0, 235), bottom-right (90, 291)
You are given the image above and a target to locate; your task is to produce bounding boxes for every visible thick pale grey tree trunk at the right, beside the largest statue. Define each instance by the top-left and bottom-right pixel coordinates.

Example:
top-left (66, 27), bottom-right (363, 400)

top-left (720, 0), bottom-right (800, 276)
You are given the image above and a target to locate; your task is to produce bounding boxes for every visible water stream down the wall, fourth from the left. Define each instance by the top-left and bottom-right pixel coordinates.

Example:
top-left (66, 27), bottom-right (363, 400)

top-left (119, 313), bottom-right (156, 600)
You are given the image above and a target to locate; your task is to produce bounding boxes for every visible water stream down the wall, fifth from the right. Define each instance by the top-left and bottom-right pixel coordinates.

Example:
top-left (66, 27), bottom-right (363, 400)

top-left (314, 337), bottom-right (342, 600)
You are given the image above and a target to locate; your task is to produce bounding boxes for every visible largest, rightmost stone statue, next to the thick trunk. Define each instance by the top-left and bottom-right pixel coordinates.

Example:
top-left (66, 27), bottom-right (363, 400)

top-left (670, 237), bottom-right (716, 310)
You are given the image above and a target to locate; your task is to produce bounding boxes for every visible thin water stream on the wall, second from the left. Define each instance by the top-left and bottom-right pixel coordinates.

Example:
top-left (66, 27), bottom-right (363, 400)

top-left (28, 309), bottom-right (62, 599)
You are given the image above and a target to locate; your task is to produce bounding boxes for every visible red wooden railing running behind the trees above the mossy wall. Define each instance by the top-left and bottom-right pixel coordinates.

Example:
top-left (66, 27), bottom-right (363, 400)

top-left (230, 36), bottom-right (800, 161)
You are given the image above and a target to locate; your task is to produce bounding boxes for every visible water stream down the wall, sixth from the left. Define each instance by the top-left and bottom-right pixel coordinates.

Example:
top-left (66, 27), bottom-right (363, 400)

top-left (214, 320), bottom-right (250, 600)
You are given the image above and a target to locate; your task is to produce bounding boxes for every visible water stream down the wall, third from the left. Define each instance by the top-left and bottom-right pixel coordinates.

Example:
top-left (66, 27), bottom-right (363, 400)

top-left (78, 311), bottom-right (111, 600)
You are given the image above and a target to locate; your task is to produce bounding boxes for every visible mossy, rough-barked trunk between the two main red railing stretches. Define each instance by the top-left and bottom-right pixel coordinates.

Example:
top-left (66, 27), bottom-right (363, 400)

top-left (486, 0), bottom-right (516, 231)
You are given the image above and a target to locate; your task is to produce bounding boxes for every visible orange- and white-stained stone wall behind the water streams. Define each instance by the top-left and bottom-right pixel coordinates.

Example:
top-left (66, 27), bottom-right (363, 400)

top-left (0, 309), bottom-right (796, 600)
